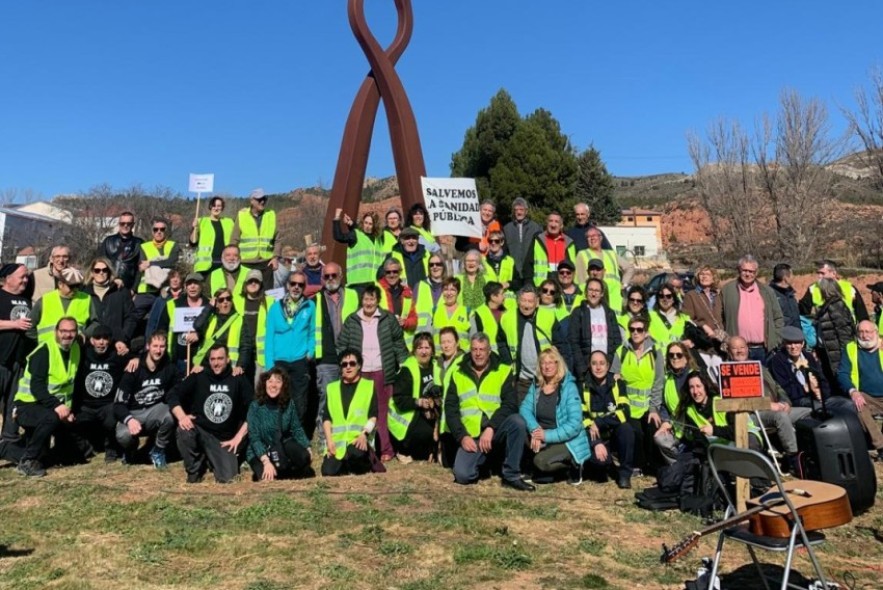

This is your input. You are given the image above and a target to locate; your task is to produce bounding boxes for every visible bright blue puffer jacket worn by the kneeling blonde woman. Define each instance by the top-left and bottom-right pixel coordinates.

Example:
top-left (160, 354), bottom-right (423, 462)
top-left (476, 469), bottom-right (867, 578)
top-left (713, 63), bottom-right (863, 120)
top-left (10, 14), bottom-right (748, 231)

top-left (519, 372), bottom-right (591, 463)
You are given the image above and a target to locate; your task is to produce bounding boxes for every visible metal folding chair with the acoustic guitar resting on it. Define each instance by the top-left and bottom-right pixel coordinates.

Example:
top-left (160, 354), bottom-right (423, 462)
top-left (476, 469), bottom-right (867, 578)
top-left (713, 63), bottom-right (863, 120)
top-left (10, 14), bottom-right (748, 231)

top-left (708, 444), bottom-right (828, 590)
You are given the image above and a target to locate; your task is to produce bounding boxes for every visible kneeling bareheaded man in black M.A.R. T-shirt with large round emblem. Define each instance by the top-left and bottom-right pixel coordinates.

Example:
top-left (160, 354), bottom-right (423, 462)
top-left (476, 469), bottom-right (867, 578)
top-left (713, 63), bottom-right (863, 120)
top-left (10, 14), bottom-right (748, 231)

top-left (169, 344), bottom-right (254, 483)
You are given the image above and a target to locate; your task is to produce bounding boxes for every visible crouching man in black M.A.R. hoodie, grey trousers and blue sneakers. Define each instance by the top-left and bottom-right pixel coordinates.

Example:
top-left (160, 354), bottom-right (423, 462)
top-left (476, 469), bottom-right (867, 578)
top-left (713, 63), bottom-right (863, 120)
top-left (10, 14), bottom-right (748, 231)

top-left (113, 330), bottom-right (175, 469)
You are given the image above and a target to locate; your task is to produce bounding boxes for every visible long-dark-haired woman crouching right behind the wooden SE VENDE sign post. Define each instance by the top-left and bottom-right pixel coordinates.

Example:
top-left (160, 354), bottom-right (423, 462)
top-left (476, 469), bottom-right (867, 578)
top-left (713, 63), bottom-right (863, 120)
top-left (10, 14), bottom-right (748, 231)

top-left (677, 371), bottom-right (762, 451)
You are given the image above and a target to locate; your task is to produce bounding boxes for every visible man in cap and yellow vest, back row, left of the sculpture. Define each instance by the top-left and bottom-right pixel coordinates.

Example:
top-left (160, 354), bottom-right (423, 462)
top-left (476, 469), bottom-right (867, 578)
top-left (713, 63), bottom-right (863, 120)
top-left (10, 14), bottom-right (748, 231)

top-left (230, 188), bottom-right (282, 285)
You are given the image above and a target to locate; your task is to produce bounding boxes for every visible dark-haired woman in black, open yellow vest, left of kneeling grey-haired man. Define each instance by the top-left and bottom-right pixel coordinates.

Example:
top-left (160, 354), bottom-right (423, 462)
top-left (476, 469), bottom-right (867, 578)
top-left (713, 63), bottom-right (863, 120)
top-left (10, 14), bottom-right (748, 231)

top-left (389, 332), bottom-right (442, 463)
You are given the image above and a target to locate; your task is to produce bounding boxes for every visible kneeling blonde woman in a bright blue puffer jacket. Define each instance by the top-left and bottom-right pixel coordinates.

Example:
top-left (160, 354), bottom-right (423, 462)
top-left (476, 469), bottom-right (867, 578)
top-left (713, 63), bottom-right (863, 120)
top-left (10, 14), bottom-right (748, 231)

top-left (520, 347), bottom-right (589, 484)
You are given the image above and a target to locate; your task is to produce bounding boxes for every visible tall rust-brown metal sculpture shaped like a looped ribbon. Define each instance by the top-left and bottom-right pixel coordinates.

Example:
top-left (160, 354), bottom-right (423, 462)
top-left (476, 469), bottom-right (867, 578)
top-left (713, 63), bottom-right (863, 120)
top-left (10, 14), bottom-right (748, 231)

top-left (322, 0), bottom-right (426, 265)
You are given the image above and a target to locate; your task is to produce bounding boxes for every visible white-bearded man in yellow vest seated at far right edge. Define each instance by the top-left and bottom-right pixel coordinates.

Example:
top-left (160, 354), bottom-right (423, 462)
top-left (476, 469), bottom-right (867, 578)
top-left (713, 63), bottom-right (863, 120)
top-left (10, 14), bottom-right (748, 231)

top-left (837, 320), bottom-right (883, 461)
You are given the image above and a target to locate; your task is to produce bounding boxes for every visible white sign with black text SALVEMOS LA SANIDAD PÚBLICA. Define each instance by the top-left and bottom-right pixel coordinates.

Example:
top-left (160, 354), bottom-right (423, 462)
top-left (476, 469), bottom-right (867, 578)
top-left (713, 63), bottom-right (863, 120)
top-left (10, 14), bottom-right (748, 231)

top-left (420, 176), bottom-right (482, 238)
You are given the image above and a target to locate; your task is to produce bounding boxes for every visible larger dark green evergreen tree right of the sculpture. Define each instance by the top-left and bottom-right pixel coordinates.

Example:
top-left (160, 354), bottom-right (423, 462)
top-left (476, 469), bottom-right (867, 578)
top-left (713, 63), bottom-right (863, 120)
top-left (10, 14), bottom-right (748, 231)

top-left (451, 90), bottom-right (577, 219)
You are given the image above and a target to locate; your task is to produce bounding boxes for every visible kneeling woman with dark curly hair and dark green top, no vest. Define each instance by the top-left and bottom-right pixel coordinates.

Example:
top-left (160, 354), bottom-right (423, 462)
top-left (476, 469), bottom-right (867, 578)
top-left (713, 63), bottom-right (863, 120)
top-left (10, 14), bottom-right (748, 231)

top-left (246, 368), bottom-right (313, 481)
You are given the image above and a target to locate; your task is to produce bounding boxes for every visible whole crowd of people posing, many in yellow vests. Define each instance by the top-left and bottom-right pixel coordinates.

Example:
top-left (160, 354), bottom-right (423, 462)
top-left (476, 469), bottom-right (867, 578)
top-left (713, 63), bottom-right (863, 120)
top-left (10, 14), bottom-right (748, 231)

top-left (0, 191), bottom-right (883, 491)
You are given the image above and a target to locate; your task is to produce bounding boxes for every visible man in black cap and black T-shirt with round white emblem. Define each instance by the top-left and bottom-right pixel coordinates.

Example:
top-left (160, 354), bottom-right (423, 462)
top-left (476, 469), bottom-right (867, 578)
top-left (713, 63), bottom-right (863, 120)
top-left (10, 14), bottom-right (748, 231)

top-left (73, 324), bottom-right (138, 463)
